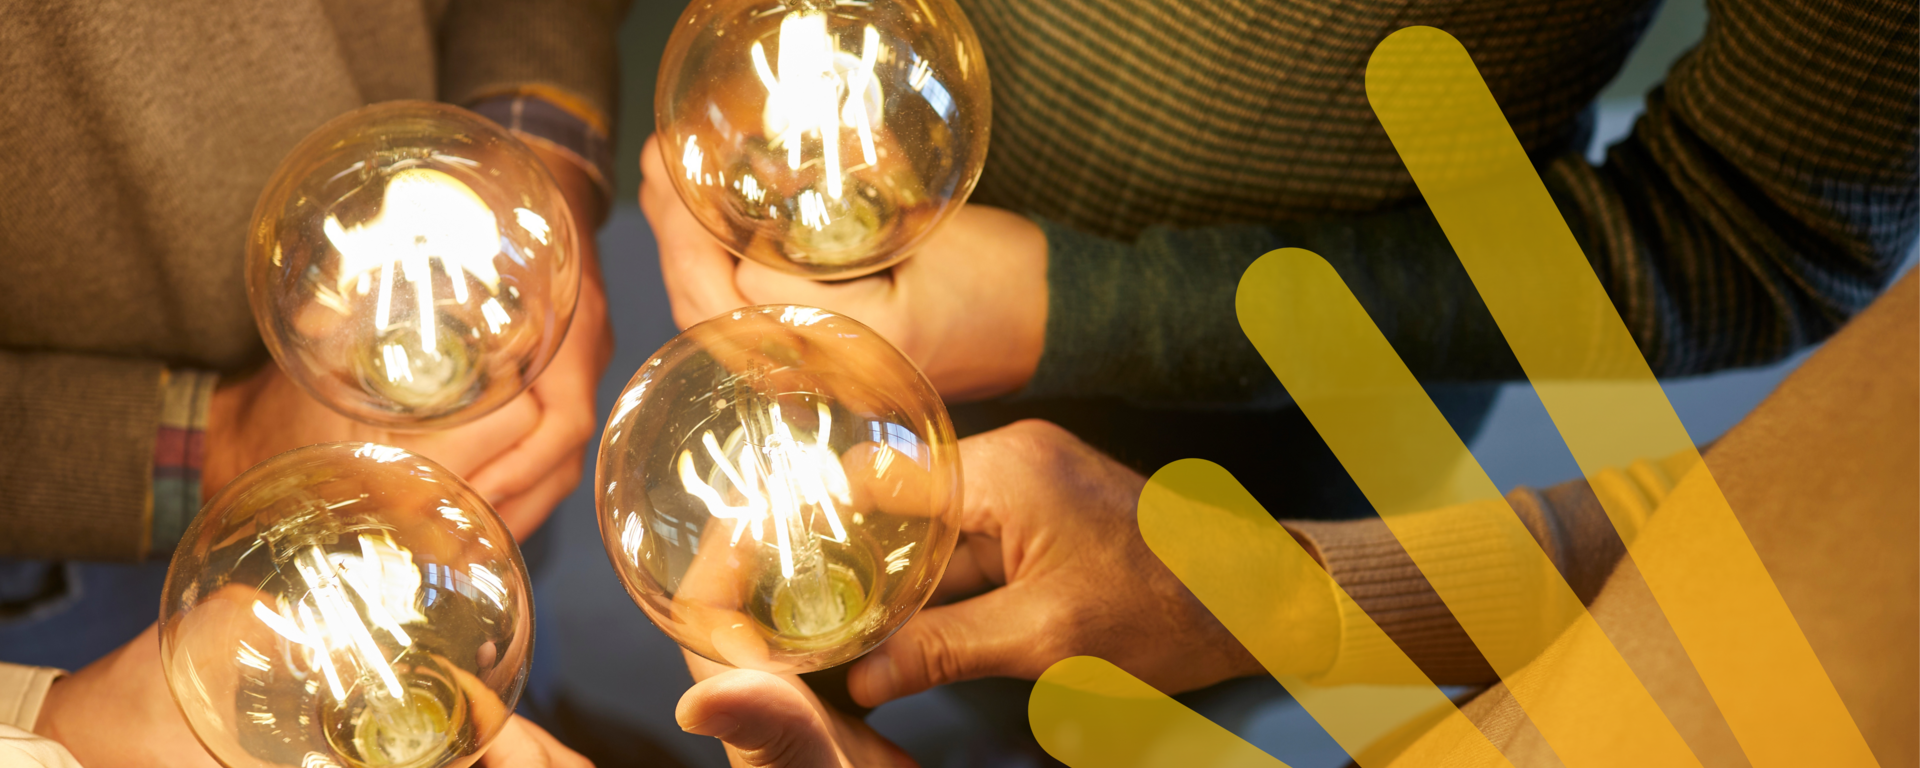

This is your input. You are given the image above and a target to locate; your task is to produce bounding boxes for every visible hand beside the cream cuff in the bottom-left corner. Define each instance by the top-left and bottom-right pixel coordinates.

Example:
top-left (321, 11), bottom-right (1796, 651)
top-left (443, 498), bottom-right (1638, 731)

top-left (33, 624), bottom-right (219, 768)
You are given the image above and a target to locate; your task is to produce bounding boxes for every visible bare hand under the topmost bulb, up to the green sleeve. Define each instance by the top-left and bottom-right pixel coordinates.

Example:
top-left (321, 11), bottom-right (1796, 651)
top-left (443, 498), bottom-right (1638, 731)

top-left (639, 138), bottom-right (1046, 399)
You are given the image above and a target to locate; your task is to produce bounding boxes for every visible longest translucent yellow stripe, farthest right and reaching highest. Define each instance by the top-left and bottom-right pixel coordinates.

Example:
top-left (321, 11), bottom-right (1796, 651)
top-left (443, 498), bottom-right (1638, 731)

top-left (1367, 27), bottom-right (1878, 768)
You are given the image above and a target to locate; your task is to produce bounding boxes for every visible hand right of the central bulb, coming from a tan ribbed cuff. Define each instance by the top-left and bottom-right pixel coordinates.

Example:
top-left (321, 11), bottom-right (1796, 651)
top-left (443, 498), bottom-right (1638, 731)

top-left (847, 420), bottom-right (1261, 707)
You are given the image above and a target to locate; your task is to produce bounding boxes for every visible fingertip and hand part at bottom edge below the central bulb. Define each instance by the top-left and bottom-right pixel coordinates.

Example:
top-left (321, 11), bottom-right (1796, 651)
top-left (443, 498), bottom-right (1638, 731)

top-left (674, 653), bottom-right (916, 768)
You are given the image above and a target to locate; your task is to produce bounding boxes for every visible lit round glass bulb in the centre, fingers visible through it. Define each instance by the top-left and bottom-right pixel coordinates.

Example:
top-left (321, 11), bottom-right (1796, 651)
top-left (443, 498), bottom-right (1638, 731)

top-left (595, 305), bottom-right (960, 674)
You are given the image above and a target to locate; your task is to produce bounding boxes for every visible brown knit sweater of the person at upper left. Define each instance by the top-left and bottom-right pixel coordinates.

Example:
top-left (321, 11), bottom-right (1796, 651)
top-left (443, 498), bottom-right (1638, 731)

top-left (0, 0), bottom-right (624, 559)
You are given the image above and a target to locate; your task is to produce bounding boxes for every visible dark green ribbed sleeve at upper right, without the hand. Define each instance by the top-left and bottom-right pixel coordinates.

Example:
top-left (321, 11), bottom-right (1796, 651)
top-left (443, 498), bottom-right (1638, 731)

top-left (1023, 0), bottom-right (1920, 403)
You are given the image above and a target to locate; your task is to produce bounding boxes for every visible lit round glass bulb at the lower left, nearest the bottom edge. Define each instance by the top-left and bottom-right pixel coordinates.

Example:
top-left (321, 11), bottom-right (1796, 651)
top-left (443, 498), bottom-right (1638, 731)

top-left (159, 444), bottom-right (534, 768)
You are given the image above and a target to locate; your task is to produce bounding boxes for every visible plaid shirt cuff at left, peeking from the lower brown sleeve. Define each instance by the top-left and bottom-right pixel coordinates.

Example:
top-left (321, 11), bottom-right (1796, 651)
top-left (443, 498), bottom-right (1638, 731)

top-left (150, 369), bottom-right (219, 555)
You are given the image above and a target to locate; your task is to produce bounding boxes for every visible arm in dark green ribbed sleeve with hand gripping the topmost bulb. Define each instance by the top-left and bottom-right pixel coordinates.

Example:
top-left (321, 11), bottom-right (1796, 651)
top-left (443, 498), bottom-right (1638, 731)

top-left (641, 0), bottom-right (1920, 407)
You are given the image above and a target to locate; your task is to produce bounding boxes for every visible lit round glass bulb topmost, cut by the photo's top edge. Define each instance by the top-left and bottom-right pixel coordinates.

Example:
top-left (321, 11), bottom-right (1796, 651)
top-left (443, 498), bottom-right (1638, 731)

top-left (655, 0), bottom-right (991, 278)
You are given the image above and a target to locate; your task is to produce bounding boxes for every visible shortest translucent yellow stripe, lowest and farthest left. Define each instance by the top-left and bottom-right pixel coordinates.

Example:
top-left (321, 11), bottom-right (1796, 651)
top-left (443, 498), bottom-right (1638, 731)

top-left (1027, 657), bottom-right (1286, 768)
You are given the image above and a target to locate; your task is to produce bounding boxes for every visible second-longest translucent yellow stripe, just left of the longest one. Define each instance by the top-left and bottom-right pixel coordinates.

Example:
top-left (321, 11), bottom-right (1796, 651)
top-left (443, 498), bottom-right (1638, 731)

top-left (1236, 248), bottom-right (1699, 768)
